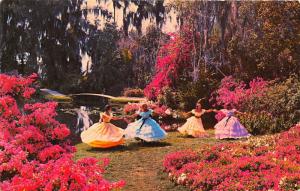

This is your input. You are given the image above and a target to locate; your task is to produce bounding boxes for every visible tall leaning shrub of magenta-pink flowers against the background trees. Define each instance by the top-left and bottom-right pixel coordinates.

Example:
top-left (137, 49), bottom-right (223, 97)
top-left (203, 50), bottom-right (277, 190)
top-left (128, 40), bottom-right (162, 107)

top-left (144, 26), bottom-right (193, 100)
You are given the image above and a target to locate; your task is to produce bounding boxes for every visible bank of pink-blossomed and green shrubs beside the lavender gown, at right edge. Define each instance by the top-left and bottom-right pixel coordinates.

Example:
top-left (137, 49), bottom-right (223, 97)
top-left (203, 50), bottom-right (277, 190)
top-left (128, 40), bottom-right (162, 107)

top-left (211, 77), bottom-right (300, 135)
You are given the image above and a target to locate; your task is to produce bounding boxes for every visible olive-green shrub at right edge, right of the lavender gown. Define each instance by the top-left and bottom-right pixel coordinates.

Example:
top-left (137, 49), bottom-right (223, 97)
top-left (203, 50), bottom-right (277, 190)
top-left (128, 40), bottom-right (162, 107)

top-left (240, 77), bottom-right (300, 135)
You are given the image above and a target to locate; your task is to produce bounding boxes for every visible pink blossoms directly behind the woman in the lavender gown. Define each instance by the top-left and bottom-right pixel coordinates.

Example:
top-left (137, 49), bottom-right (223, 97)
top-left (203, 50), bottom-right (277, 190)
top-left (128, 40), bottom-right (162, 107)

top-left (211, 76), bottom-right (269, 110)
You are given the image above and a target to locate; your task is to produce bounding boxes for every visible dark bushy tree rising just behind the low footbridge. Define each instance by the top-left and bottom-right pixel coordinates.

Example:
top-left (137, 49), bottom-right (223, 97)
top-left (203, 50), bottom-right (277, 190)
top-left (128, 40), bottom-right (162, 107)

top-left (86, 24), bottom-right (129, 95)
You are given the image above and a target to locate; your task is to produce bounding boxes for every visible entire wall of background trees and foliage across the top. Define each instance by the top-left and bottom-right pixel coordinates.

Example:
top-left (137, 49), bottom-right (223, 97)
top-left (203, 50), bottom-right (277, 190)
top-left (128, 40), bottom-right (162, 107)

top-left (0, 0), bottom-right (300, 98)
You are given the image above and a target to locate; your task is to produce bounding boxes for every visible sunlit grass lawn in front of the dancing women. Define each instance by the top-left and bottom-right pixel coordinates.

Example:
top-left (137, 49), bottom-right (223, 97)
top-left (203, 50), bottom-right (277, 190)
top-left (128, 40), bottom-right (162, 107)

top-left (75, 130), bottom-right (234, 191)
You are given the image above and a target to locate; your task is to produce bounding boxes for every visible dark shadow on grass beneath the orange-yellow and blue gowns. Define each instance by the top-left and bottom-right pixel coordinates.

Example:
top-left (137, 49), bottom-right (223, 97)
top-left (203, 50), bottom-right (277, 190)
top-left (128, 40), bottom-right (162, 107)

top-left (86, 141), bottom-right (172, 153)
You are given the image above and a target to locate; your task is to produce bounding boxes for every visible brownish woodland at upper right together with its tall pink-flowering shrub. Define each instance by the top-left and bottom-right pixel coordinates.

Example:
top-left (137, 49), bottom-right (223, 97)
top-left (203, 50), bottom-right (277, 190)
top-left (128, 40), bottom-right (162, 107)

top-left (145, 1), bottom-right (300, 109)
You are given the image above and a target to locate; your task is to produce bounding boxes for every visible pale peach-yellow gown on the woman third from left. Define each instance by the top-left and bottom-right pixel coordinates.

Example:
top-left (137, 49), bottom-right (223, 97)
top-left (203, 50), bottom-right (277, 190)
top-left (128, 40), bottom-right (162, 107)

top-left (178, 109), bottom-right (208, 137)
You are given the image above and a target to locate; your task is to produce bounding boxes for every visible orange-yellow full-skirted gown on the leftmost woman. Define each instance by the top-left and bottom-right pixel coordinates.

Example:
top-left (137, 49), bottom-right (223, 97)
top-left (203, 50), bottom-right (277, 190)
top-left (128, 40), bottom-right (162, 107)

top-left (81, 113), bottom-right (124, 148)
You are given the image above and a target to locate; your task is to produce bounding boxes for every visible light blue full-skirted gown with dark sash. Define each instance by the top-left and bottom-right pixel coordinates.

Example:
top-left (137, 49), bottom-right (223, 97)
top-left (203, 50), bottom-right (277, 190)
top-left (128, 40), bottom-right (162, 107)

top-left (124, 110), bottom-right (167, 142)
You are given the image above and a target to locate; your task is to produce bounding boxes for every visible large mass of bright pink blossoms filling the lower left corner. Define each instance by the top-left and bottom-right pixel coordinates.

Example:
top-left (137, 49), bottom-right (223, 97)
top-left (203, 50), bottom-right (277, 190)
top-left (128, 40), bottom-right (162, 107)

top-left (0, 74), bottom-right (124, 191)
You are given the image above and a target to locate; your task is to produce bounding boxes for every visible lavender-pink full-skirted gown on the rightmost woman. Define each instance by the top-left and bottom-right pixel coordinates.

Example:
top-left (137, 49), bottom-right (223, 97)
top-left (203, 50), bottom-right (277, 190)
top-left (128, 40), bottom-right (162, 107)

top-left (215, 109), bottom-right (251, 139)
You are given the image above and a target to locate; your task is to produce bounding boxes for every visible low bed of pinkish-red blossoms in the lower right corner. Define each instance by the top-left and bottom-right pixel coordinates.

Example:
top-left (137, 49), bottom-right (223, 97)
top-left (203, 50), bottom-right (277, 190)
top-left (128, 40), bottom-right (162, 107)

top-left (164, 125), bottom-right (300, 191)
